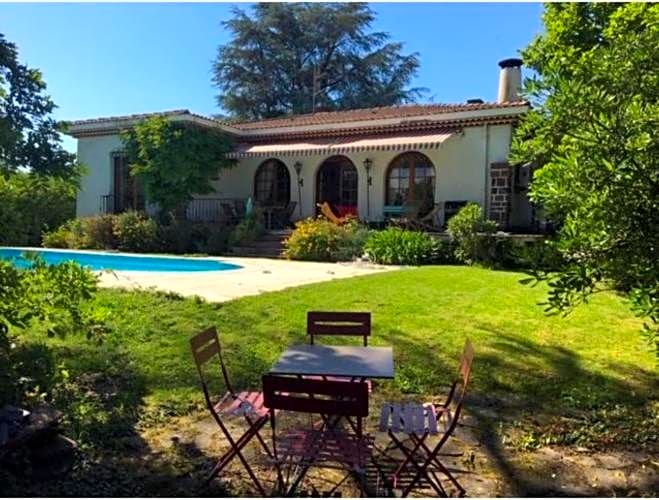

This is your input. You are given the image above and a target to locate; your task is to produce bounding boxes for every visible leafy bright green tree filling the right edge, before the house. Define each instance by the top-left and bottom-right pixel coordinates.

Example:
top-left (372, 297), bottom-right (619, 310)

top-left (513, 3), bottom-right (659, 354)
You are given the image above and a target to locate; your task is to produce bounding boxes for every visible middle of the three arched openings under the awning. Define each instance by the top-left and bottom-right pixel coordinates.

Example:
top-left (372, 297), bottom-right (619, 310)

top-left (316, 156), bottom-right (357, 217)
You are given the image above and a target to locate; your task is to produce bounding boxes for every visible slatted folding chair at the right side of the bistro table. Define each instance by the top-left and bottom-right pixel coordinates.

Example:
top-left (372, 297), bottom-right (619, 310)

top-left (379, 340), bottom-right (474, 496)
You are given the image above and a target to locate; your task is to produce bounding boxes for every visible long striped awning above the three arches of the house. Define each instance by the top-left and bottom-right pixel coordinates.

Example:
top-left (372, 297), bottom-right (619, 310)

top-left (227, 129), bottom-right (458, 158)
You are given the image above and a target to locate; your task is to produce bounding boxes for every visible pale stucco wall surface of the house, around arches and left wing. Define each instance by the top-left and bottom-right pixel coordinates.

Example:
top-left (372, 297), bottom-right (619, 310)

top-left (77, 125), bottom-right (511, 221)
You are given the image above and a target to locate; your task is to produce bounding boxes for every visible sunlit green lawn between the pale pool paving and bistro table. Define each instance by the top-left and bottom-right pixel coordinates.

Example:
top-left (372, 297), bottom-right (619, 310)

top-left (25, 266), bottom-right (656, 414)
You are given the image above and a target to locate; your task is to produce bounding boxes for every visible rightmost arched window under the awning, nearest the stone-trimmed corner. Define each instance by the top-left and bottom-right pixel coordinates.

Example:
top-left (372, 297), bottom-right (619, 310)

top-left (386, 152), bottom-right (435, 215)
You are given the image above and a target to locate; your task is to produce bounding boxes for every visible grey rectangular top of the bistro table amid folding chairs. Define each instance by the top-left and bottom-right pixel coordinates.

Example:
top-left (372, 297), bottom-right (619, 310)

top-left (270, 344), bottom-right (394, 379)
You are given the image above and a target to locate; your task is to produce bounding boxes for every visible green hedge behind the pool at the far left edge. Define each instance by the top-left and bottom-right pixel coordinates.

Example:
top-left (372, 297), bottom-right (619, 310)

top-left (0, 172), bottom-right (77, 246)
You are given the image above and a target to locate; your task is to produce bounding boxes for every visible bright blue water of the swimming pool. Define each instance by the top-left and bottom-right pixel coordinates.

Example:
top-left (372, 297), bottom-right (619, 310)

top-left (0, 248), bottom-right (241, 272)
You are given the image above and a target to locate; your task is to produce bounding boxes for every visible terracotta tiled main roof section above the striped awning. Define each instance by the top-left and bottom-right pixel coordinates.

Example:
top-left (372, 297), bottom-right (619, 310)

top-left (223, 102), bottom-right (527, 130)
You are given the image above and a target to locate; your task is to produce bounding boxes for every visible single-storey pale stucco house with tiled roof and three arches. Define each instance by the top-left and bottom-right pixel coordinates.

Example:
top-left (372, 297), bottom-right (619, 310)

top-left (68, 59), bottom-right (535, 229)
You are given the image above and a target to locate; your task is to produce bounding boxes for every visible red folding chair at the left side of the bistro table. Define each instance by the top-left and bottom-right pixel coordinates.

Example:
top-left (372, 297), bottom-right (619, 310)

top-left (190, 327), bottom-right (274, 496)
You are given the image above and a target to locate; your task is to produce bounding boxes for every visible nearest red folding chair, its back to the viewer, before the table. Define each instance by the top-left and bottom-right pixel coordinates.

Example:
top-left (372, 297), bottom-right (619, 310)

top-left (263, 375), bottom-right (373, 495)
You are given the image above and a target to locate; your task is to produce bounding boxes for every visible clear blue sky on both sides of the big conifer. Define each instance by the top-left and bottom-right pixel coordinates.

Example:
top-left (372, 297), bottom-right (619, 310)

top-left (0, 3), bottom-right (542, 148)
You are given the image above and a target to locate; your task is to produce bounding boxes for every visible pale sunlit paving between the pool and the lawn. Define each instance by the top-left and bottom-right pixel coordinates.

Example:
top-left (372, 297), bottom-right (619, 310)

top-left (101, 257), bottom-right (398, 302)
